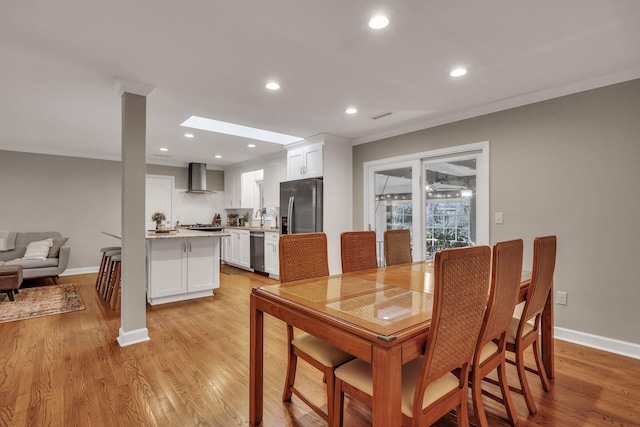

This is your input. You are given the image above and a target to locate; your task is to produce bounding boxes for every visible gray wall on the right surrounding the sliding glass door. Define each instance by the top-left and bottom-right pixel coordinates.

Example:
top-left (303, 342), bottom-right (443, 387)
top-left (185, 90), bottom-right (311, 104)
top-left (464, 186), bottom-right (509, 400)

top-left (353, 80), bottom-right (640, 344)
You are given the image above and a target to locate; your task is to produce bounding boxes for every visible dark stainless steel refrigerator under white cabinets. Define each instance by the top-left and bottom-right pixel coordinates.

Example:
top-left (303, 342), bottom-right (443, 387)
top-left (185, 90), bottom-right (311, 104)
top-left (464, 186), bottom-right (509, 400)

top-left (279, 178), bottom-right (322, 234)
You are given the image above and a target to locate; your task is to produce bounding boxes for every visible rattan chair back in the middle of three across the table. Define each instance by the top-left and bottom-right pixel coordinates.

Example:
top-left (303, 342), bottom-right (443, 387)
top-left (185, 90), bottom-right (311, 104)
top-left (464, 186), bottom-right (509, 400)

top-left (340, 231), bottom-right (378, 273)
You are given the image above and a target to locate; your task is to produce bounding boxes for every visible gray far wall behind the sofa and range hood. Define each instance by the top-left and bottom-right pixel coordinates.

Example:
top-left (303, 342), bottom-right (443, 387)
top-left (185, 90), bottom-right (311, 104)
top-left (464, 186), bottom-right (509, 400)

top-left (0, 150), bottom-right (224, 269)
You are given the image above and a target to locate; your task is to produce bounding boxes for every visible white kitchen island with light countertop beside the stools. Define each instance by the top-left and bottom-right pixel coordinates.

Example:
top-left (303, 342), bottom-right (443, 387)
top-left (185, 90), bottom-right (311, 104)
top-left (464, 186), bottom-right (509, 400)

top-left (146, 229), bottom-right (228, 305)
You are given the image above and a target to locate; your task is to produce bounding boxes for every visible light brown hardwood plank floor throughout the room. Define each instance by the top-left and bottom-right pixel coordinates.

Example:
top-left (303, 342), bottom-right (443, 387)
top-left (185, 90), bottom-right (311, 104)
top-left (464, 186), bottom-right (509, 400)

top-left (0, 273), bottom-right (640, 427)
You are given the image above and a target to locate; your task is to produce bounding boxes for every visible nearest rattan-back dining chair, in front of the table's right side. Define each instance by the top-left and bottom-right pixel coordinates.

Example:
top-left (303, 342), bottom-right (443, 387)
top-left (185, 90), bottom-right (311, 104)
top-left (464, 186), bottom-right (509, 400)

top-left (333, 246), bottom-right (491, 426)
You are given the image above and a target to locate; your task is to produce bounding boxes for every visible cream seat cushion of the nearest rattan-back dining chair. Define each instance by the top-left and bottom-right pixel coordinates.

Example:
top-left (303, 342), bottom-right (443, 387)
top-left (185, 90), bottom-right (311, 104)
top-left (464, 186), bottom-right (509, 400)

top-left (336, 357), bottom-right (460, 417)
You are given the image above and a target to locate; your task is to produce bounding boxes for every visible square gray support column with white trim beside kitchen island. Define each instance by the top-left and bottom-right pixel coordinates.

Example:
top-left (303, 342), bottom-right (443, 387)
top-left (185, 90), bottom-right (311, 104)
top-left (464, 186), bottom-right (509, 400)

top-left (114, 79), bottom-right (154, 347)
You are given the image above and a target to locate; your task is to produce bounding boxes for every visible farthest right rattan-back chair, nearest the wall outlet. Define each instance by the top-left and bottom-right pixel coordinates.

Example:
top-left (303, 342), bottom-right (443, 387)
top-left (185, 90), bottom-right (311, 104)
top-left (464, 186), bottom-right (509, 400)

top-left (506, 236), bottom-right (557, 415)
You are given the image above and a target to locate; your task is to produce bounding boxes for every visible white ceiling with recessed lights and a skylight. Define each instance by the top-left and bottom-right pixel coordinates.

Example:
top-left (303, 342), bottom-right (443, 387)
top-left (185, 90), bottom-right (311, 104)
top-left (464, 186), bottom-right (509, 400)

top-left (0, 0), bottom-right (640, 169)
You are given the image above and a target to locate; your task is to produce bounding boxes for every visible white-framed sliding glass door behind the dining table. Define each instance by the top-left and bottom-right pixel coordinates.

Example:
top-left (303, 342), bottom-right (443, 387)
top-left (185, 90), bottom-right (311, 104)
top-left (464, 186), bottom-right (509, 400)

top-left (364, 142), bottom-right (489, 266)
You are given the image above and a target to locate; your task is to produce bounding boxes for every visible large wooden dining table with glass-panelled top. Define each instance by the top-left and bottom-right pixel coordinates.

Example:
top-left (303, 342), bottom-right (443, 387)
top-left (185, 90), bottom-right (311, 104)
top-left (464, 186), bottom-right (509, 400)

top-left (249, 261), bottom-right (553, 426)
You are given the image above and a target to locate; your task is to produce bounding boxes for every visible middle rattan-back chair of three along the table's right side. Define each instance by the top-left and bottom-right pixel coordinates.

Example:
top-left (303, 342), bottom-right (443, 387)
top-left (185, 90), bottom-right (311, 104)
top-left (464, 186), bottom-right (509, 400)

top-left (471, 239), bottom-right (523, 427)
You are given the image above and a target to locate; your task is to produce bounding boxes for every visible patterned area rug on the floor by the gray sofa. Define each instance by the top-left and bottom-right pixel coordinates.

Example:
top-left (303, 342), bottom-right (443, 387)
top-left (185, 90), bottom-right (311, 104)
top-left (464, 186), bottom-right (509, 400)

top-left (0, 283), bottom-right (84, 323)
